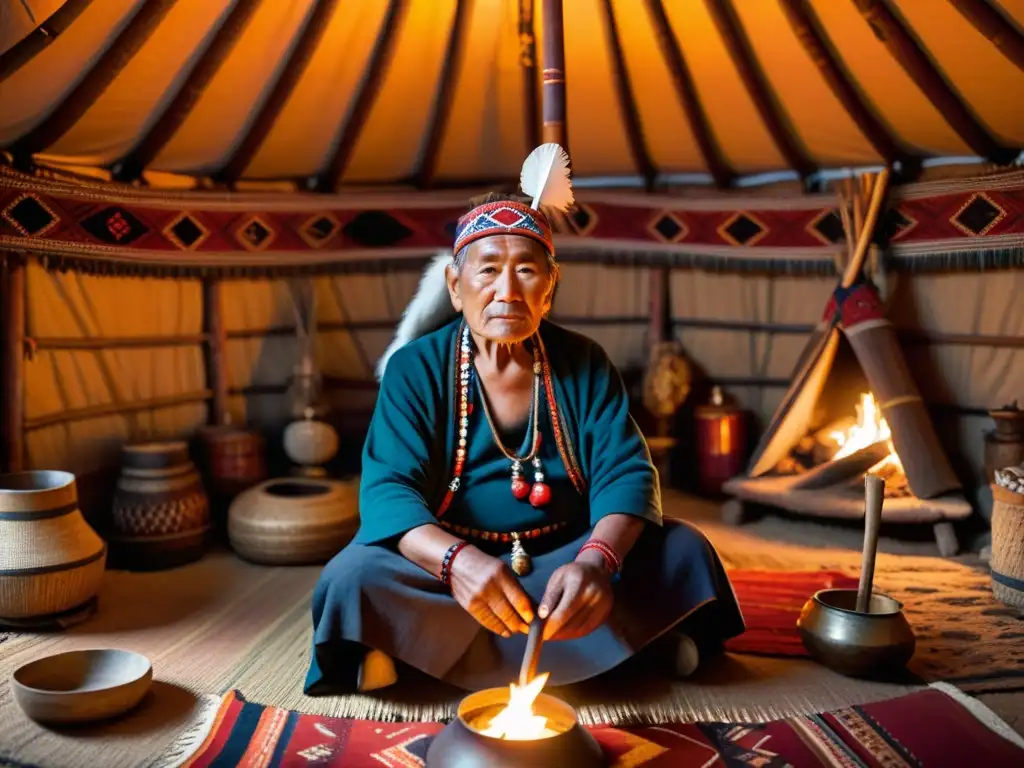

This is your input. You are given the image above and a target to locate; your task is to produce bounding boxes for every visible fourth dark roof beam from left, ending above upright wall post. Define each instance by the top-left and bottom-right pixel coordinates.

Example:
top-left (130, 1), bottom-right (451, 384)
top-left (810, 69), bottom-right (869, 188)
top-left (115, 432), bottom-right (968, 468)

top-left (211, 0), bottom-right (338, 184)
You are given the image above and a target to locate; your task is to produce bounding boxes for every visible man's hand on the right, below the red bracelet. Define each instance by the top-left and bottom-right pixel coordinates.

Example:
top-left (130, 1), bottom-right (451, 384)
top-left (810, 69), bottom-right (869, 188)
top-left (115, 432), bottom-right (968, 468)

top-left (537, 561), bottom-right (613, 640)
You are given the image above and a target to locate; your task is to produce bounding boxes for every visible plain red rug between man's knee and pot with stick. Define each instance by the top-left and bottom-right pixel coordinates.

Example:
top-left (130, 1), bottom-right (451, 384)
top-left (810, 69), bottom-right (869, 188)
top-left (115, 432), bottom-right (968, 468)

top-left (725, 569), bottom-right (857, 656)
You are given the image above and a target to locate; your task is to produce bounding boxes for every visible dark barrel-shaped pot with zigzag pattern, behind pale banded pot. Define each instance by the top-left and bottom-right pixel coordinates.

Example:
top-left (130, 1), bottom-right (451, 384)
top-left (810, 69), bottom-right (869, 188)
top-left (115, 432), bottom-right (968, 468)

top-left (111, 441), bottom-right (210, 570)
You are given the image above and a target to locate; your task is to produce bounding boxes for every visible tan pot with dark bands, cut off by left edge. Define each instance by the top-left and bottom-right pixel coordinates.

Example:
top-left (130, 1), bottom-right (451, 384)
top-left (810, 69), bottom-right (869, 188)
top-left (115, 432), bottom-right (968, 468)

top-left (0, 471), bottom-right (106, 630)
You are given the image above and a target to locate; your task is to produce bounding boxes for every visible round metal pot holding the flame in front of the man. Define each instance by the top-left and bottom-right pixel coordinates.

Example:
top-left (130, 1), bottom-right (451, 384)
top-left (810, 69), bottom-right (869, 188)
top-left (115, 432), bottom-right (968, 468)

top-left (426, 688), bottom-right (607, 768)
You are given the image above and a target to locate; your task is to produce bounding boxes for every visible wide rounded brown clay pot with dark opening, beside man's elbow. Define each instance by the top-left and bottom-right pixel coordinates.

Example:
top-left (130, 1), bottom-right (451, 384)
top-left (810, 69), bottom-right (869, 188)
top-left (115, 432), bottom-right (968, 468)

top-left (227, 477), bottom-right (359, 565)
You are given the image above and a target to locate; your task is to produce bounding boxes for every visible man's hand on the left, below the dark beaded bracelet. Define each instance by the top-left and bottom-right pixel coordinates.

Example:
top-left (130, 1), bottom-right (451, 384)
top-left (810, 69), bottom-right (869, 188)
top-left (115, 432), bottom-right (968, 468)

top-left (452, 547), bottom-right (534, 637)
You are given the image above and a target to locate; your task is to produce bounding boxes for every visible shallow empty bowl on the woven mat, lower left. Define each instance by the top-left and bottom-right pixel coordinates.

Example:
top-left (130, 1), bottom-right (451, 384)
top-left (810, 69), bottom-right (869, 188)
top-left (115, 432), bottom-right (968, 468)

top-left (11, 648), bottom-right (153, 723)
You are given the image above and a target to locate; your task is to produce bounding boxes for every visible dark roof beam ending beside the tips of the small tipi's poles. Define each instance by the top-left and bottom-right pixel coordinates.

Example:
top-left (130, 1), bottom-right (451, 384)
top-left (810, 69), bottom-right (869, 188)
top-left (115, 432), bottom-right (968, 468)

top-left (779, 0), bottom-right (912, 165)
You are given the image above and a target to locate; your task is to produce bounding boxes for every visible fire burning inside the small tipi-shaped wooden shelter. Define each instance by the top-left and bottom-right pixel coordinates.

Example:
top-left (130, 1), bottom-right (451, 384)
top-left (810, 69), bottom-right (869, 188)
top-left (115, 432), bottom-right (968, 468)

top-left (775, 392), bottom-right (910, 498)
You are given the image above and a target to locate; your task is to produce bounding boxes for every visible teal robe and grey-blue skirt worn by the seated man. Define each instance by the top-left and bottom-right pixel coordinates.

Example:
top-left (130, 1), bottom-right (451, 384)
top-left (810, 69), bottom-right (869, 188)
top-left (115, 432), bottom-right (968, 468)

top-left (306, 321), bottom-right (742, 694)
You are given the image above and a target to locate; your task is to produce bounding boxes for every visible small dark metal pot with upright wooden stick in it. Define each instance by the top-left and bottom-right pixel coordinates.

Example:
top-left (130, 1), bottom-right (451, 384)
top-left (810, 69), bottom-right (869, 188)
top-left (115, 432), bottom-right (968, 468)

top-left (797, 589), bottom-right (915, 678)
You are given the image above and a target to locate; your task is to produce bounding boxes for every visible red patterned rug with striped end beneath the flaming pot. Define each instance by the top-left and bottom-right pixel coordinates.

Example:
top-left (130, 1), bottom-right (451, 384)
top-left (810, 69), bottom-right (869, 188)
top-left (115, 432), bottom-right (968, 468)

top-left (174, 688), bottom-right (1024, 768)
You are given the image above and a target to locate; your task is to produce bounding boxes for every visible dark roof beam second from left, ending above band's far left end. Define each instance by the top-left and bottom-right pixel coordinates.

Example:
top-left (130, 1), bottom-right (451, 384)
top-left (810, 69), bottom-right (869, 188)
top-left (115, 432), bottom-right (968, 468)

top-left (7, 0), bottom-right (174, 163)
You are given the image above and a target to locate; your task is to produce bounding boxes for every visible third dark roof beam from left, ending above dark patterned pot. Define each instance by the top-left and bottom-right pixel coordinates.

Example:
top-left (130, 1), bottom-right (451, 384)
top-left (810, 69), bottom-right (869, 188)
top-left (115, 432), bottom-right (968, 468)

top-left (111, 0), bottom-right (260, 181)
